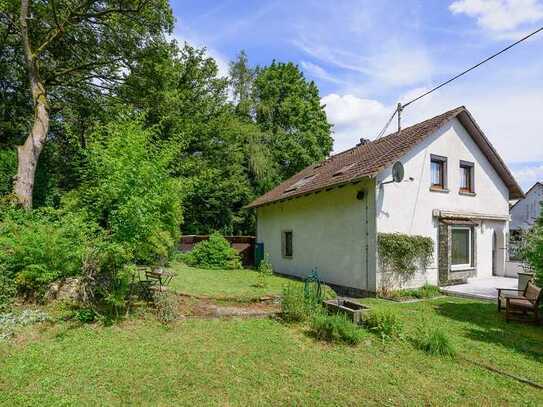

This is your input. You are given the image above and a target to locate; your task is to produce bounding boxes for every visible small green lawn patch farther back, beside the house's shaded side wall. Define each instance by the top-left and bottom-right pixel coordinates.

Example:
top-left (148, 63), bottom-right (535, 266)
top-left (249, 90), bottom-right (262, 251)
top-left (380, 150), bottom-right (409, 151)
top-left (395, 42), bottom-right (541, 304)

top-left (170, 263), bottom-right (302, 301)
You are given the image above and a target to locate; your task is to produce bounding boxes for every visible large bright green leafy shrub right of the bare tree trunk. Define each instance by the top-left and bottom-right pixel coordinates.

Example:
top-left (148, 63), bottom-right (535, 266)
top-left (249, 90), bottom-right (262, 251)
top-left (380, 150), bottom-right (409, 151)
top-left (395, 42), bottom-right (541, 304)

top-left (63, 117), bottom-right (182, 264)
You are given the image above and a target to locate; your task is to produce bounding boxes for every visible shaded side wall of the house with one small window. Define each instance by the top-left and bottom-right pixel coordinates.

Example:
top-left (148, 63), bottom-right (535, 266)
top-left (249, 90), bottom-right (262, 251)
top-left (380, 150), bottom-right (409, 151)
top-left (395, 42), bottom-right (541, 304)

top-left (257, 180), bottom-right (375, 291)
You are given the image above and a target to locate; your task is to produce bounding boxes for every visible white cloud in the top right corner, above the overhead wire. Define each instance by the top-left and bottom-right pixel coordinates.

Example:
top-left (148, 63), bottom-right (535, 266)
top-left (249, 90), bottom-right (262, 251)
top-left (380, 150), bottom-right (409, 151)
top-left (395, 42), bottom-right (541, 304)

top-left (449, 0), bottom-right (543, 34)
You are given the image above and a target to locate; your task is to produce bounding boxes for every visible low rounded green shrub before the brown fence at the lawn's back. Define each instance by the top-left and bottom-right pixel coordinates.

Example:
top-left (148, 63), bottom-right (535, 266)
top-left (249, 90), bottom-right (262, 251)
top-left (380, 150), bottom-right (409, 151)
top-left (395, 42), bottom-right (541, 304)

top-left (185, 232), bottom-right (241, 270)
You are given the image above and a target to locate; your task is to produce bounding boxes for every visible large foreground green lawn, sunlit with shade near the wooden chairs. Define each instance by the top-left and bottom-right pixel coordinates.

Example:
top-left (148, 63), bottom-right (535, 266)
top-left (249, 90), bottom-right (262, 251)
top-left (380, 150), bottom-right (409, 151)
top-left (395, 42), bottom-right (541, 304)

top-left (0, 298), bottom-right (543, 406)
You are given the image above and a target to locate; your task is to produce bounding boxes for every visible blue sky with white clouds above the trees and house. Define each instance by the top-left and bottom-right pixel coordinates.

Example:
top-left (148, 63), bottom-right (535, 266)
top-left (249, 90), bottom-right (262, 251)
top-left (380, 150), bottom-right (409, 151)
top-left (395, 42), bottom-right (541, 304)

top-left (171, 0), bottom-right (543, 189)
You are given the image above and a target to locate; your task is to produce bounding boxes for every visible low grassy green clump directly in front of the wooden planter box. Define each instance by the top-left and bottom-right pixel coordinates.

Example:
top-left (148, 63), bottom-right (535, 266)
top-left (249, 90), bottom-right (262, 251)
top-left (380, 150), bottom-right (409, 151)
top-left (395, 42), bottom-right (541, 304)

top-left (311, 310), bottom-right (365, 345)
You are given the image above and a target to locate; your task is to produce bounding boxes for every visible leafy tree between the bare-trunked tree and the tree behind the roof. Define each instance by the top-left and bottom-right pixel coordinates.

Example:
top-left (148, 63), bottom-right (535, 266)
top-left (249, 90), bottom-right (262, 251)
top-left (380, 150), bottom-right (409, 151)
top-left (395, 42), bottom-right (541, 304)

top-left (119, 43), bottom-right (253, 234)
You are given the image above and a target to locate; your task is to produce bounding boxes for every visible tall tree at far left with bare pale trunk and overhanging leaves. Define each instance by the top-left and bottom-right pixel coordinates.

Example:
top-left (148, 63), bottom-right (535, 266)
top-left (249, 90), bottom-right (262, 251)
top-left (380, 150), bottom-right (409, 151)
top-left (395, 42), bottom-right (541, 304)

top-left (0, 0), bottom-right (173, 208)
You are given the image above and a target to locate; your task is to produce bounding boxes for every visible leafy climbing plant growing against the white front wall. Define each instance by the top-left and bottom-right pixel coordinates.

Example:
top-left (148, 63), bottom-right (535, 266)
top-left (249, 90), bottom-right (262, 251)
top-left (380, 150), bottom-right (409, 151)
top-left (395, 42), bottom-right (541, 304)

top-left (377, 233), bottom-right (434, 288)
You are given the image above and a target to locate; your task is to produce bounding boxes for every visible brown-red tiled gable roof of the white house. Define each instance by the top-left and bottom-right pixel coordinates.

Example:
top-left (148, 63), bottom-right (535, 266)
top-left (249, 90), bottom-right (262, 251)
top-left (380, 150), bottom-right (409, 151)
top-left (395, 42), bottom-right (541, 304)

top-left (247, 106), bottom-right (524, 208)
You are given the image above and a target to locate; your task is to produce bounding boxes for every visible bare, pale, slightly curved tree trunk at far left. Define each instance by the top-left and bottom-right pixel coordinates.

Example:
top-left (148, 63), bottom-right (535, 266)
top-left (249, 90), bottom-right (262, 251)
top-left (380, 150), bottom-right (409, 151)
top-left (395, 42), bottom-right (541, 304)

top-left (14, 0), bottom-right (49, 210)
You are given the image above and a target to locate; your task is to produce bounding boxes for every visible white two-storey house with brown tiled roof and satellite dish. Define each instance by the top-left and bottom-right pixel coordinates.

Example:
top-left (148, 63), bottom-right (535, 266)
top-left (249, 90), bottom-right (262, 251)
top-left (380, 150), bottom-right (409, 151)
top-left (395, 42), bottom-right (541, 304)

top-left (248, 107), bottom-right (524, 295)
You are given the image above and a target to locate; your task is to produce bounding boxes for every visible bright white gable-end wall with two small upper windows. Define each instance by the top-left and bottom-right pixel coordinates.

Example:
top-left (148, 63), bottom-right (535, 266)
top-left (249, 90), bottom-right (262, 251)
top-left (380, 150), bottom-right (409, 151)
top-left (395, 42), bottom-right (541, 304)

top-left (376, 119), bottom-right (509, 286)
